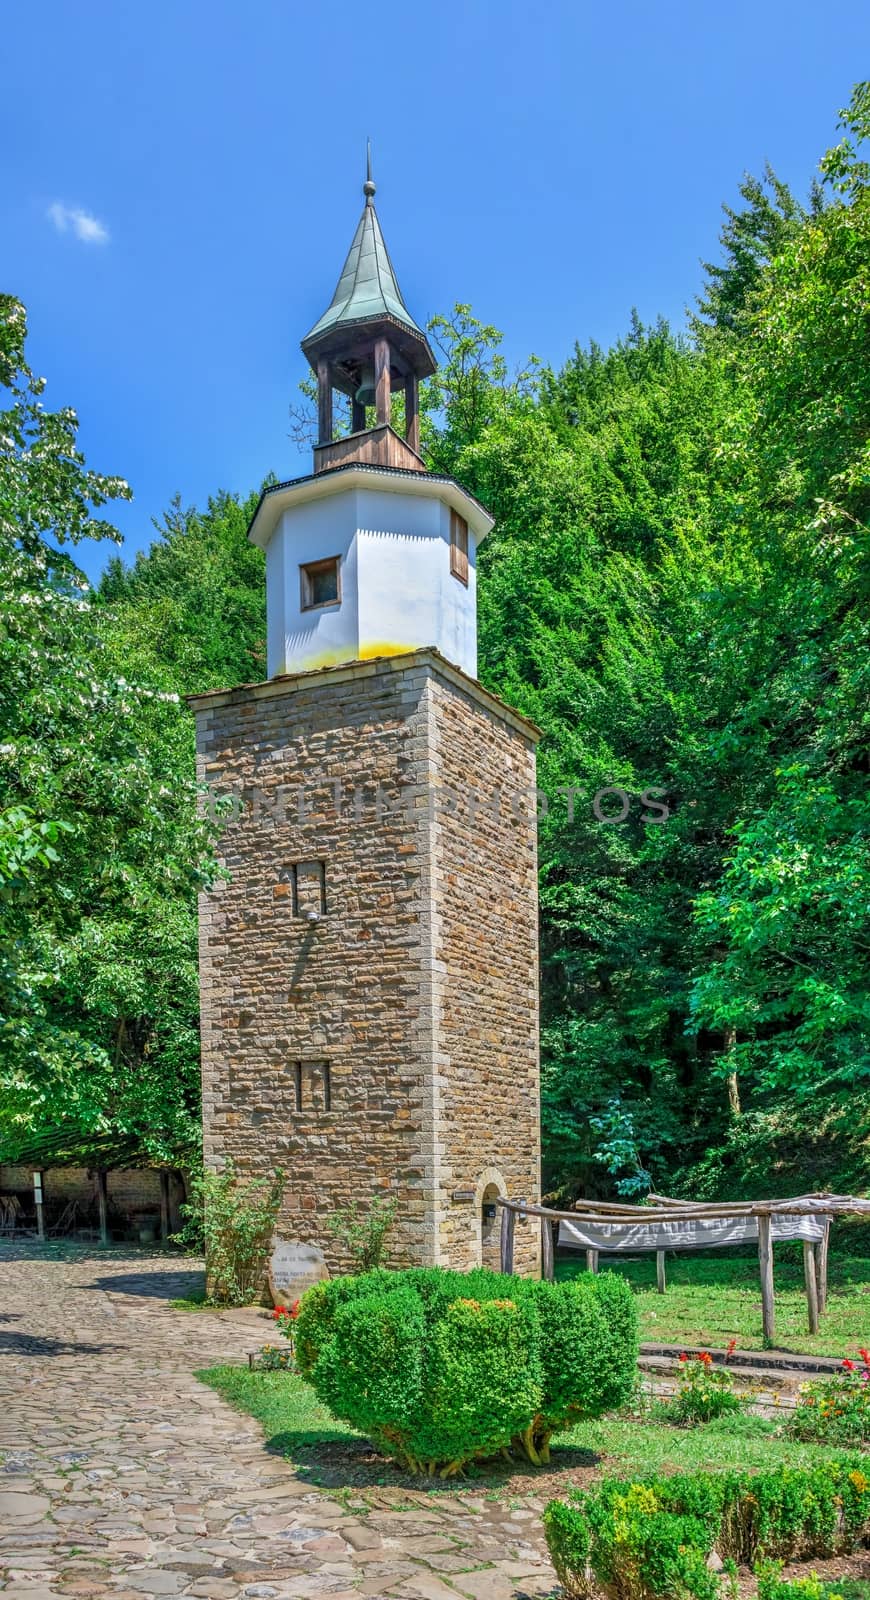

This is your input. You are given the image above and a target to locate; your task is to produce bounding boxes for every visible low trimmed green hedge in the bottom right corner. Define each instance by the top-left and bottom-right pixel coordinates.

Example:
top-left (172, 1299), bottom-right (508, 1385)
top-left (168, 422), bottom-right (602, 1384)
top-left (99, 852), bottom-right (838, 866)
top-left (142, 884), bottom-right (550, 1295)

top-left (544, 1456), bottom-right (870, 1600)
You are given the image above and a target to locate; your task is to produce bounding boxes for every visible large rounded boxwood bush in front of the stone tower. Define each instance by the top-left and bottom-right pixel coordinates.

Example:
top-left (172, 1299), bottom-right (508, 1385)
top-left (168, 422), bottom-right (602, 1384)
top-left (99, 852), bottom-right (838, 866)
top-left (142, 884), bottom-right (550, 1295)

top-left (294, 1267), bottom-right (638, 1477)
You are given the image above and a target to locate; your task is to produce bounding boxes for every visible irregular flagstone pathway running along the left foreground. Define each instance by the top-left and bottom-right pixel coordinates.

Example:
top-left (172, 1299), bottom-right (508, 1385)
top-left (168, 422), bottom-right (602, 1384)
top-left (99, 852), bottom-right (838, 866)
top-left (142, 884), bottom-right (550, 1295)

top-left (0, 1242), bottom-right (558, 1600)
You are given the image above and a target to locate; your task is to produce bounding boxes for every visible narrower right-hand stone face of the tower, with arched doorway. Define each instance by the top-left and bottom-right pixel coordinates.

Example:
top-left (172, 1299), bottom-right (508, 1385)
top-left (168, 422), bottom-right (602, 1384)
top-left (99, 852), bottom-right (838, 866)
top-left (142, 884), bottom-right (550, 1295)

top-left (430, 675), bottom-right (541, 1275)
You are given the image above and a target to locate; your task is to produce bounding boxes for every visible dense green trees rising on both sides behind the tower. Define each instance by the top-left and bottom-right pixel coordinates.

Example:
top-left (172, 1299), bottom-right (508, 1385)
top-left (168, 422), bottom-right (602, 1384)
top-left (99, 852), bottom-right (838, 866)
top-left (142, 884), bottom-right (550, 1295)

top-left (0, 85), bottom-right (870, 1194)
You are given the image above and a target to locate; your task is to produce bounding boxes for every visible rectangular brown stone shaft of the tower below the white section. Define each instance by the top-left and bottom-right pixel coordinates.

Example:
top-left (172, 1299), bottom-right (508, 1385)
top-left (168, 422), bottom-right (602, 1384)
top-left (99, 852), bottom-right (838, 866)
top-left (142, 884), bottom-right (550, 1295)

top-left (194, 651), bottom-right (537, 1270)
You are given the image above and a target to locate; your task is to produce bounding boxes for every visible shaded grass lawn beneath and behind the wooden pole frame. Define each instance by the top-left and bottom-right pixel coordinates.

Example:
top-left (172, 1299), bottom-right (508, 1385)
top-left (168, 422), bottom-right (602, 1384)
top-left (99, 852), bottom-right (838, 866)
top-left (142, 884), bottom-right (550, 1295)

top-left (557, 1243), bottom-right (870, 1357)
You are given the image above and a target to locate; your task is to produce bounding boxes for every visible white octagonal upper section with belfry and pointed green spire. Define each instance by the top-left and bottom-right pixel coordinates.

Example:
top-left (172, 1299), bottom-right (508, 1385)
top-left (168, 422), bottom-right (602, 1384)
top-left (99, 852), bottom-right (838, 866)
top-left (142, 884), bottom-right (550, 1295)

top-left (251, 158), bottom-right (493, 677)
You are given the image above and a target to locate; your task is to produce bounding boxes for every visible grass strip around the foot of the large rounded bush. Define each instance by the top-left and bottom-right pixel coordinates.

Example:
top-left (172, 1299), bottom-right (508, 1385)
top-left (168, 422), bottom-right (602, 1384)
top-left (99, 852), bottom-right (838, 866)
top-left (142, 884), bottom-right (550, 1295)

top-left (197, 1366), bottom-right (857, 1496)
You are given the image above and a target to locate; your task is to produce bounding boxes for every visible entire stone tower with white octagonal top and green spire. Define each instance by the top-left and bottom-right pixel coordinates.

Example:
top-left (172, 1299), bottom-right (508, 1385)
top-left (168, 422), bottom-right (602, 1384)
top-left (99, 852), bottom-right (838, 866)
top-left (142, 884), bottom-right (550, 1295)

top-left (190, 166), bottom-right (539, 1274)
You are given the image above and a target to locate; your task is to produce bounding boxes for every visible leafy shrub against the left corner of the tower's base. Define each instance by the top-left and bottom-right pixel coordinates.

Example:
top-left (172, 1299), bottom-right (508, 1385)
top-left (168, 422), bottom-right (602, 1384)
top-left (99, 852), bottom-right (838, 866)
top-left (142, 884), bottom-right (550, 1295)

top-left (176, 1162), bottom-right (285, 1306)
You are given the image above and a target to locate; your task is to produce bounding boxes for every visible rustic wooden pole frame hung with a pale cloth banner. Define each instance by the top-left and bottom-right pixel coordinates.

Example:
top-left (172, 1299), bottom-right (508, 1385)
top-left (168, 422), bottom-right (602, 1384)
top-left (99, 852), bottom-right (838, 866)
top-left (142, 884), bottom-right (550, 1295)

top-left (497, 1194), bottom-right (870, 1344)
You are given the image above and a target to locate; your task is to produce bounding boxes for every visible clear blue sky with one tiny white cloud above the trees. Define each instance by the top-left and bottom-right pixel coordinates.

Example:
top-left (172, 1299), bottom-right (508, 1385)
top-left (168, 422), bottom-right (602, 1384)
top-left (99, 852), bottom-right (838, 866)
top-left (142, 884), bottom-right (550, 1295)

top-left (0, 0), bottom-right (870, 574)
